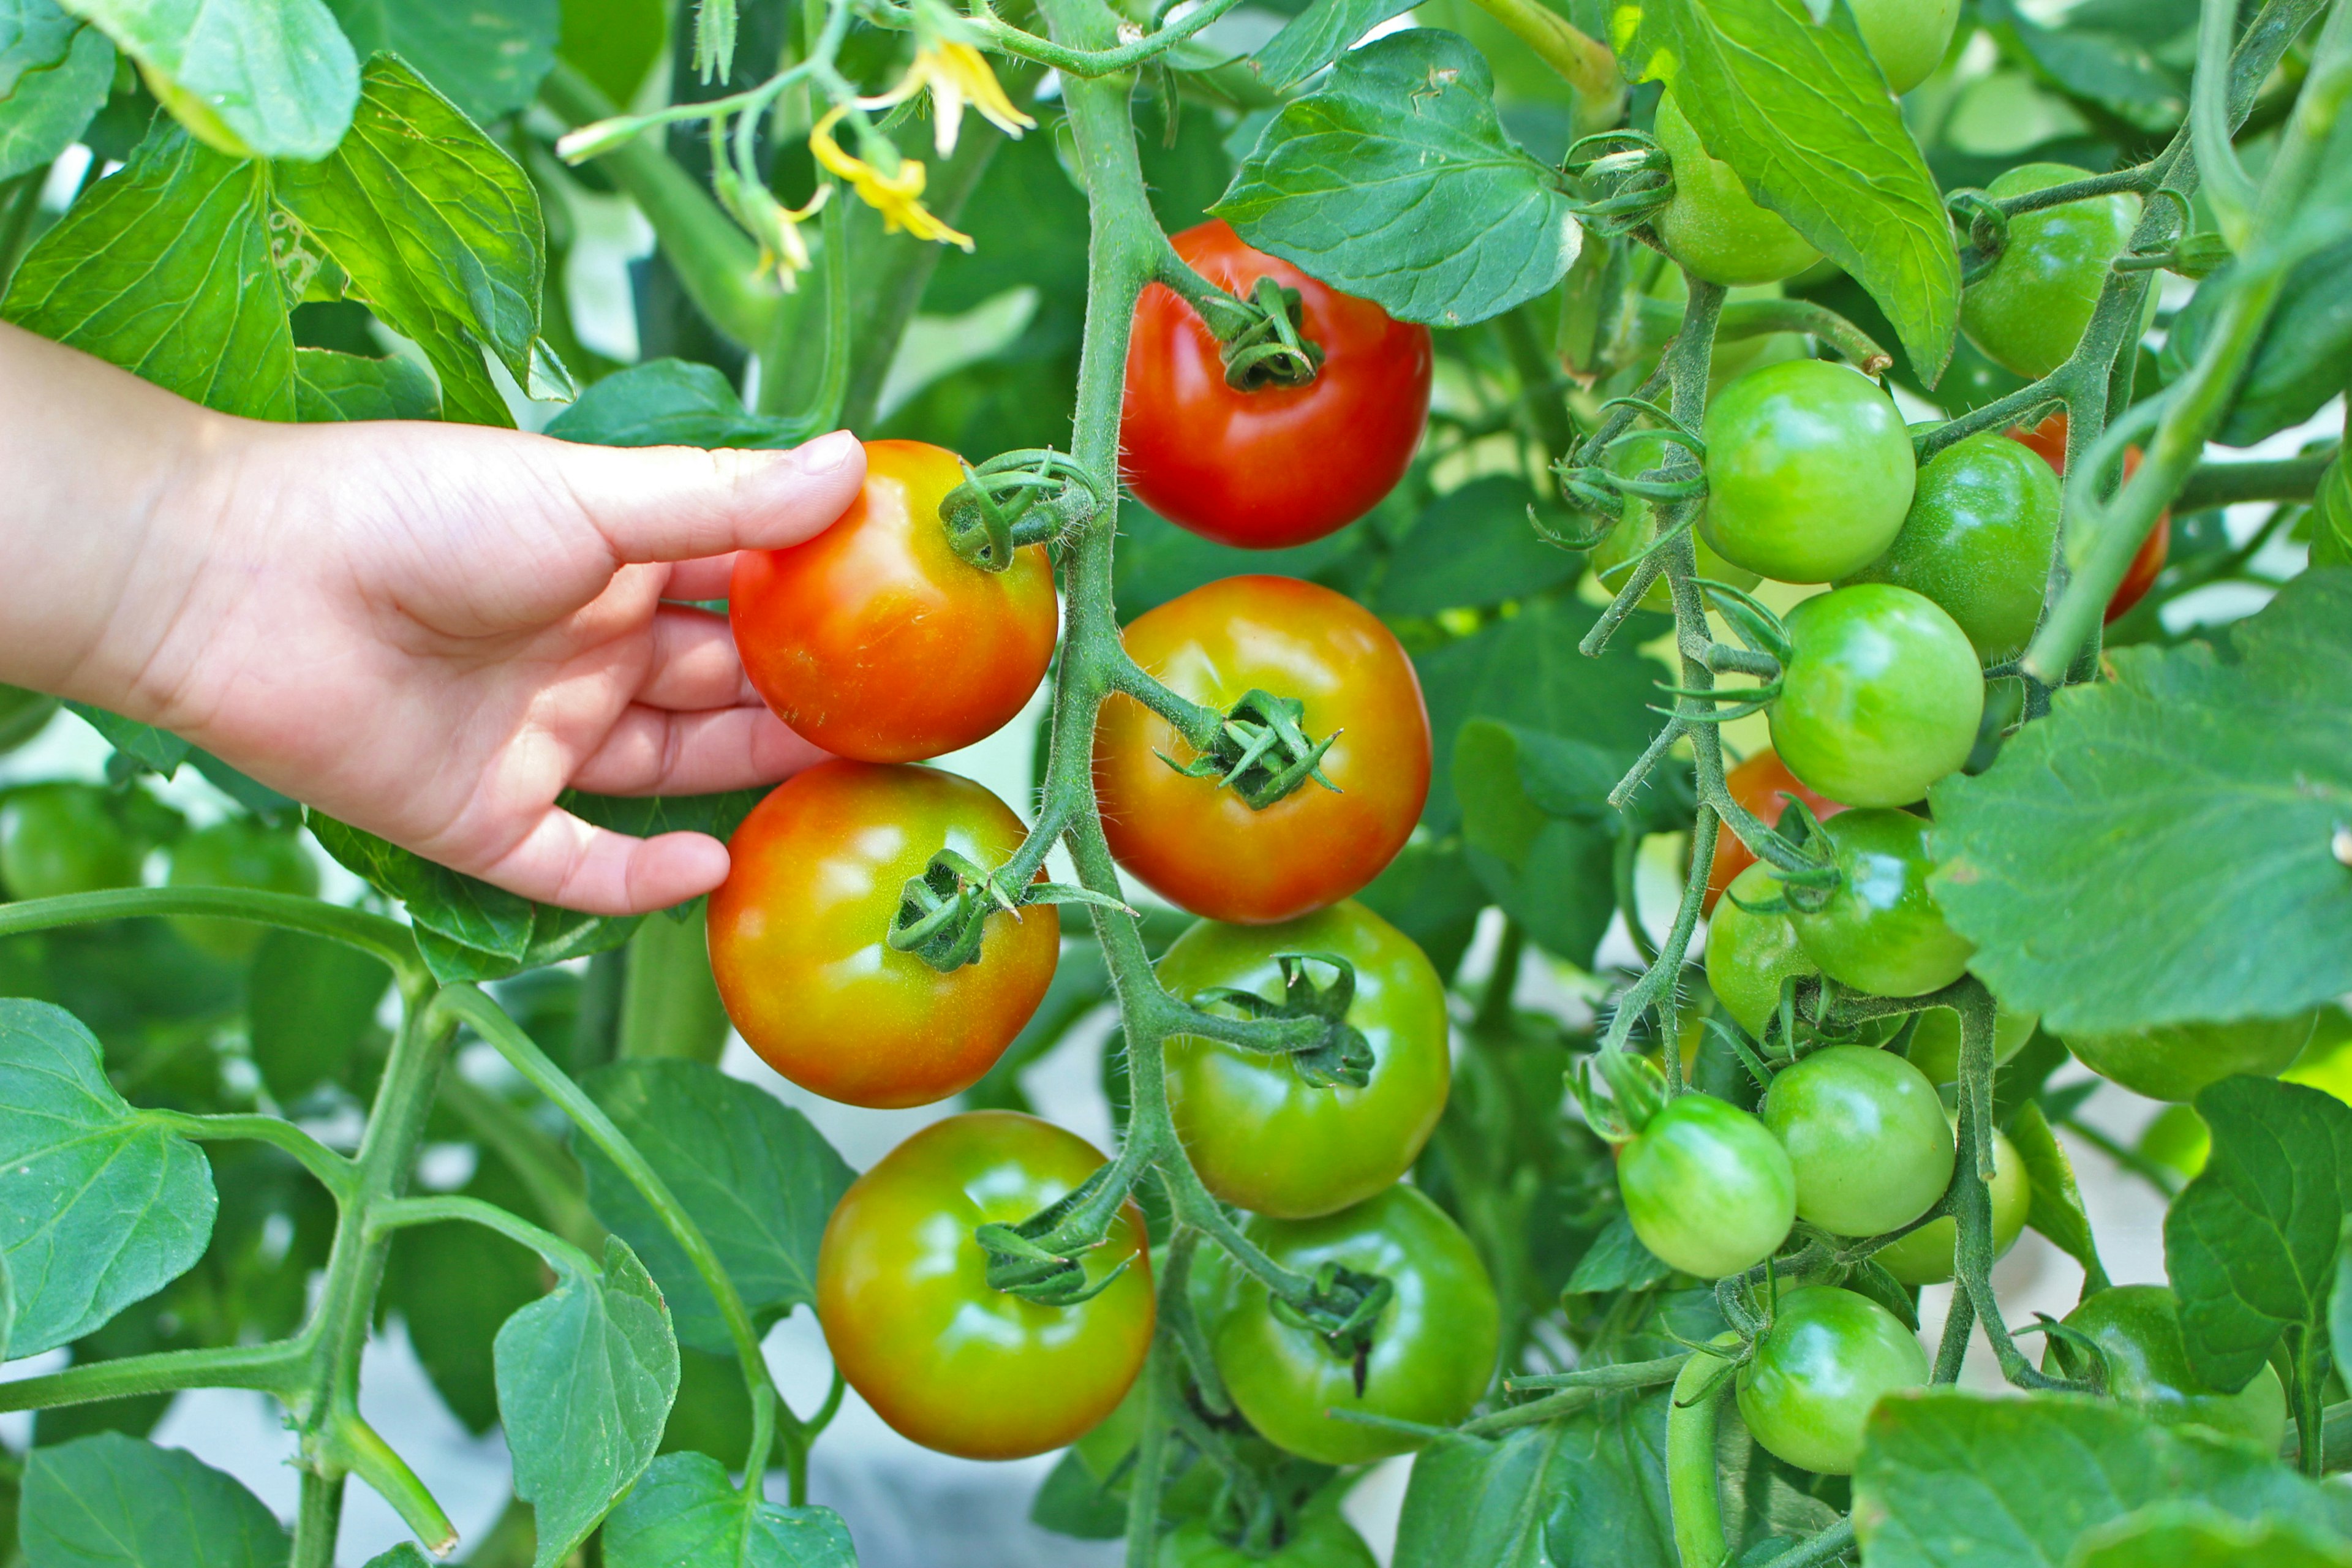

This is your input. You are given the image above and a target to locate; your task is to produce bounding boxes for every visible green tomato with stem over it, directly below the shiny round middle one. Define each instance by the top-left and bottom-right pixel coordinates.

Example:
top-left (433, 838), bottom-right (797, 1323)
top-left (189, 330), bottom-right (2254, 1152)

top-left (1790, 809), bottom-right (1976, 997)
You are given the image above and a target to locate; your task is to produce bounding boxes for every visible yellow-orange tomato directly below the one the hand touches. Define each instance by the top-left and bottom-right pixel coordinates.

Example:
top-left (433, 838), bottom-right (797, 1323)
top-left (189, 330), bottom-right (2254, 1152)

top-left (708, 762), bottom-right (1061, 1107)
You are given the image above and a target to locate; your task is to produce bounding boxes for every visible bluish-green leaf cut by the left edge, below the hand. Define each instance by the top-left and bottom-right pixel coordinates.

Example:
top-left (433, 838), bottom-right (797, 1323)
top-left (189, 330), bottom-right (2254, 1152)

top-left (0, 999), bottom-right (219, 1357)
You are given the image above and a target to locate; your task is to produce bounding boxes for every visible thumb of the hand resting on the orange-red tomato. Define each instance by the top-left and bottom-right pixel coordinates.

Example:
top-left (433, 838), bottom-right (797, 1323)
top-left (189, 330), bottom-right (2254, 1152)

top-left (529, 430), bottom-right (865, 564)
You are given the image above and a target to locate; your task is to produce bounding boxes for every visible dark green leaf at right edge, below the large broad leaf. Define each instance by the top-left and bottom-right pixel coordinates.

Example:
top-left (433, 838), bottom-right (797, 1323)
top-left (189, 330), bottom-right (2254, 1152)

top-left (2164, 1077), bottom-right (2352, 1392)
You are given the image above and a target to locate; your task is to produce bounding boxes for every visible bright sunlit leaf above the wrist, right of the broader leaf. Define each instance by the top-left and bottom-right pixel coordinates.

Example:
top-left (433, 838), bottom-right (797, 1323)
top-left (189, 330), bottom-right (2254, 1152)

top-left (277, 54), bottom-right (546, 426)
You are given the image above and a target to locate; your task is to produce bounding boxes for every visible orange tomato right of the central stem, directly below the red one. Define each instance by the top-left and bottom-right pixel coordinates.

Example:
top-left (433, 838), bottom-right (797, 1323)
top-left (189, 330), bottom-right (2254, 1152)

top-left (1094, 576), bottom-right (1430, 926)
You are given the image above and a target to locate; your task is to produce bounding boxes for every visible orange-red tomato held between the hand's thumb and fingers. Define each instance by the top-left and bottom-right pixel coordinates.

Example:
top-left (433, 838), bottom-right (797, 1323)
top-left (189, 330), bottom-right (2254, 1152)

top-left (727, 442), bottom-right (1058, 762)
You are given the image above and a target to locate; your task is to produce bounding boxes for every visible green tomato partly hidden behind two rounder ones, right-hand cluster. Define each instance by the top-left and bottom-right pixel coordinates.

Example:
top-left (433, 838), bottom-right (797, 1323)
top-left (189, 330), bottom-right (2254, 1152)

top-left (1846, 435), bottom-right (2058, 665)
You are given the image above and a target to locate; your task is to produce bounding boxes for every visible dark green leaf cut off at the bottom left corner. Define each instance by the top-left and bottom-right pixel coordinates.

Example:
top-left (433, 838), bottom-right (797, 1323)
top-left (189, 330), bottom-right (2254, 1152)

top-left (19, 1431), bottom-right (289, 1568)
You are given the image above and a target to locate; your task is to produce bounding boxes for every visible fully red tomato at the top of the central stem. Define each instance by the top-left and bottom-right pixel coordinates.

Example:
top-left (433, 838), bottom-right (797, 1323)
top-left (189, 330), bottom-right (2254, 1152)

top-left (1120, 219), bottom-right (1434, 550)
